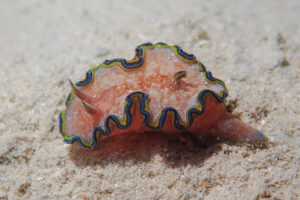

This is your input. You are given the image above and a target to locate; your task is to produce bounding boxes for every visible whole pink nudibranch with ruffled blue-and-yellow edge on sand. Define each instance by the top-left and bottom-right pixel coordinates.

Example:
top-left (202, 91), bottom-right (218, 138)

top-left (59, 43), bottom-right (267, 148)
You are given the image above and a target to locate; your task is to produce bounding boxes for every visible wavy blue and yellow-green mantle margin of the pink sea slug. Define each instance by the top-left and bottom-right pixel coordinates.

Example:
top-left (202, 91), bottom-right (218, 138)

top-left (59, 43), bottom-right (228, 148)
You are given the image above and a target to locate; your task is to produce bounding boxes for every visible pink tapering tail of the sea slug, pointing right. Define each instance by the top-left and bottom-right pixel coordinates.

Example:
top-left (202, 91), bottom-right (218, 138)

top-left (215, 113), bottom-right (268, 142)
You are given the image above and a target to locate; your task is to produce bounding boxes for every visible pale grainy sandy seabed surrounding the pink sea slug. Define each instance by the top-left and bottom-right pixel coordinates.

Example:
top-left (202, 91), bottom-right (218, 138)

top-left (0, 0), bottom-right (300, 200)
